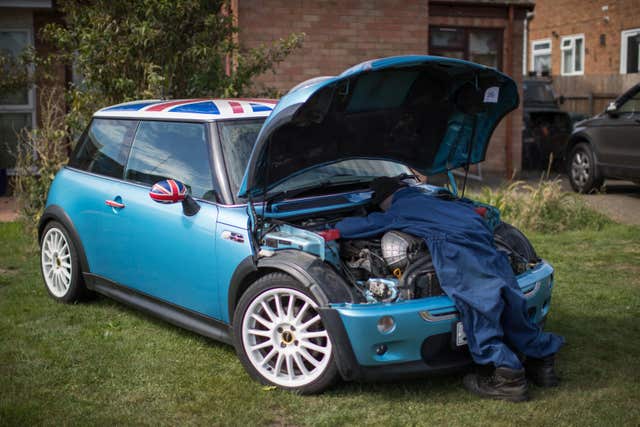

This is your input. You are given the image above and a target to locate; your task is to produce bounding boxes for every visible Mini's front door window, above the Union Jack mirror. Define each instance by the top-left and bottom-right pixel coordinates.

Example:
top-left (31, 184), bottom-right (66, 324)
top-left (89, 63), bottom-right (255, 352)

top-left (125, 121), bottom-right (216, 201)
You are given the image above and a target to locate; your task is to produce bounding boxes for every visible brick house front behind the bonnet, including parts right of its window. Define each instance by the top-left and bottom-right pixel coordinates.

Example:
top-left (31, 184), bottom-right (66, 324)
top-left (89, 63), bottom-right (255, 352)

top-left (235, 0), bottom-right (524, 175)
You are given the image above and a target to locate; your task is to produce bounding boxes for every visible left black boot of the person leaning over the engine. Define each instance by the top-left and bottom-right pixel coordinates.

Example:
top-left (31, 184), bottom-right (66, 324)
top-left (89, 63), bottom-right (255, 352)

top-left (463, 367), bottom-right (529, 402)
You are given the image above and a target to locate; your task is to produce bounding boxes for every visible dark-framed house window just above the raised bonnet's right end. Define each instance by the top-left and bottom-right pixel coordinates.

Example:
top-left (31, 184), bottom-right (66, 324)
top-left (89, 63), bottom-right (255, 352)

top-left (429, 27), bottom-right (502, 69)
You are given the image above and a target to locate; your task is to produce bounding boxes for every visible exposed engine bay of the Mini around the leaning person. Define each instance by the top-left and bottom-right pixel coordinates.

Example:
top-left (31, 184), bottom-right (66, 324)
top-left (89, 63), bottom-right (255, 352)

top-left (260, 206), bottom-right (540, 303)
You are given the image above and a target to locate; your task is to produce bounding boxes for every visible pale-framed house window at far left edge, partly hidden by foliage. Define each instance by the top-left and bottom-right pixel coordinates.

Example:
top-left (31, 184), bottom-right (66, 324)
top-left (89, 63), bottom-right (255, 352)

top-left (0, 29), bottom-right (35, 172)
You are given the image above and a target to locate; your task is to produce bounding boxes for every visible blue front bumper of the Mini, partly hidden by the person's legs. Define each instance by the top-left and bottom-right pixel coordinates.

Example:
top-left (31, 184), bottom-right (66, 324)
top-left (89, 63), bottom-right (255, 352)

top-left (320, 261), bottom-right (553, 380)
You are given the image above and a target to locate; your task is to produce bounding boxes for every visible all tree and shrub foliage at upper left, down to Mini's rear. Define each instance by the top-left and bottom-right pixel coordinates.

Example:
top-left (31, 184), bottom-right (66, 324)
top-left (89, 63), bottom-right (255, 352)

top-left (0, 0), bottom-right (304, 232)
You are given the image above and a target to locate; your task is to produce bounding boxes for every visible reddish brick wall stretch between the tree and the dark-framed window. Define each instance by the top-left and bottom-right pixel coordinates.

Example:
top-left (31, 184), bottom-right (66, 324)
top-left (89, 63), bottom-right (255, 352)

top-left (238, 0), bottom-right (428, 92)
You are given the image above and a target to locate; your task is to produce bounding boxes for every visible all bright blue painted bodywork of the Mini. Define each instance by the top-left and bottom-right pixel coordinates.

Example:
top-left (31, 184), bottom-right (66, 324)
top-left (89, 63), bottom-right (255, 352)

top-left (42, 56), bottom-right (553, 380)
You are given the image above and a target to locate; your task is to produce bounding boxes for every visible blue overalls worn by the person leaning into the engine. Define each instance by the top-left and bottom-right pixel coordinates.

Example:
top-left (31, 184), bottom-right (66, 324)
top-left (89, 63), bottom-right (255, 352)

top-left (336, 187), bottom-right (564, 369)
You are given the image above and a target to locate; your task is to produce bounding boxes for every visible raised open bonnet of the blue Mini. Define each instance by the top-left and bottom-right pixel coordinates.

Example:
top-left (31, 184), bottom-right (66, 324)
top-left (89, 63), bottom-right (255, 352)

top-left (238, 56), bottom-right (518, 197)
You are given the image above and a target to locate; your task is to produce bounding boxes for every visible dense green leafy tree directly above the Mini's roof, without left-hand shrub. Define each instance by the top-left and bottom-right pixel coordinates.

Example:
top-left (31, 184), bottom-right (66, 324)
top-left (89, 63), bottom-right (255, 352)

top-left (42, 0), bottom-right (304, 127)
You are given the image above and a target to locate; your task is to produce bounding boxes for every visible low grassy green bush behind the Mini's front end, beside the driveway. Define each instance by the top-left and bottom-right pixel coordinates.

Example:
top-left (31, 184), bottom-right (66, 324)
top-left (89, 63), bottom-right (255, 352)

top-left (472, 179), bottom-right (611, 233)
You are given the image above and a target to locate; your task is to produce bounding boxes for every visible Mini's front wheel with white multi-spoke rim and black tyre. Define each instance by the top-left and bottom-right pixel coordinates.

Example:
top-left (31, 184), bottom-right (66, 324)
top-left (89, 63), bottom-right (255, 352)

top-left (233, 273), bottom-right (338, 394)
